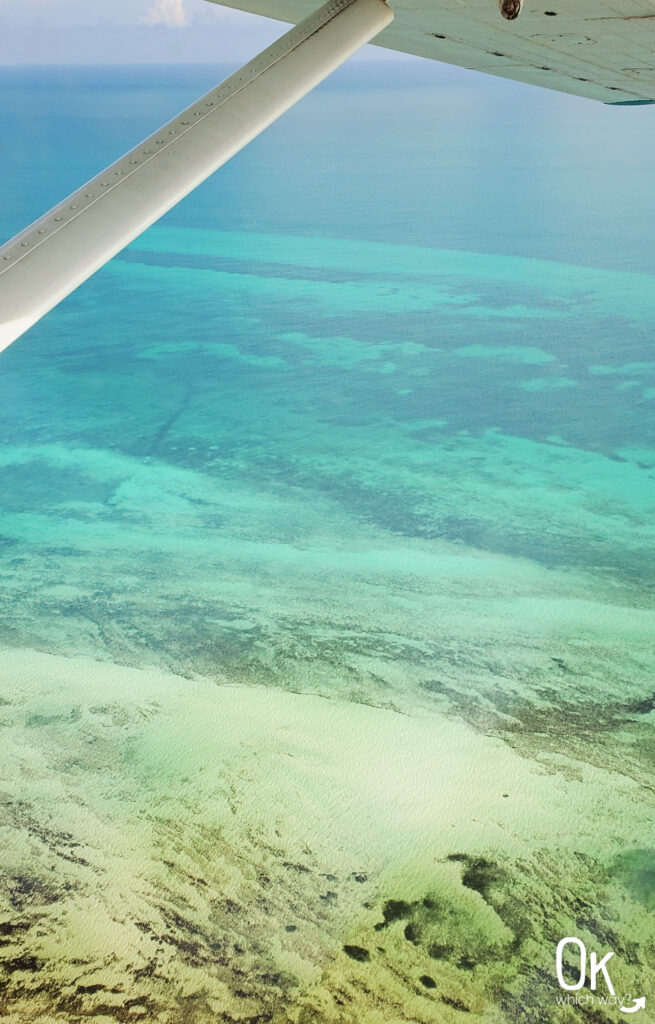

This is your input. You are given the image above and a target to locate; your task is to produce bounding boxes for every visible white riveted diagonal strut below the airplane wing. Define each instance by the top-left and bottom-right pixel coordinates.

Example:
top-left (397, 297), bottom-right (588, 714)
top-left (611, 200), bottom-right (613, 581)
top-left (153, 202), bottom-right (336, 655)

top-left (0, 0), bottom-right (393, 350)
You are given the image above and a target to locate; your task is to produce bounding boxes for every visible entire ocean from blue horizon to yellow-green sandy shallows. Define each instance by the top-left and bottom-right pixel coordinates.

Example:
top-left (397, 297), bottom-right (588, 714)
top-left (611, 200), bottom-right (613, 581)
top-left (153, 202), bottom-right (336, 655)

top-left (0, 60), bottom-right (655, 1024)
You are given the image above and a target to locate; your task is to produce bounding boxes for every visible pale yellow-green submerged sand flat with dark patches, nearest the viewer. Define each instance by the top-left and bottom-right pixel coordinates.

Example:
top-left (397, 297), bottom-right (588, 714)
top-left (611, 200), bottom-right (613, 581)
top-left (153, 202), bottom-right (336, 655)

top-left (0, 650), bottom-right (655, 1024)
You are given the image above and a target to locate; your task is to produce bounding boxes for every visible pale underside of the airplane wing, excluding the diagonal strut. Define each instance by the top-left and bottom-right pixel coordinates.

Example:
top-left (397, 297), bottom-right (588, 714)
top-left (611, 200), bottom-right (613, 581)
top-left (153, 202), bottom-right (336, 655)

top-left (208, 0), bottom-right (655, 104)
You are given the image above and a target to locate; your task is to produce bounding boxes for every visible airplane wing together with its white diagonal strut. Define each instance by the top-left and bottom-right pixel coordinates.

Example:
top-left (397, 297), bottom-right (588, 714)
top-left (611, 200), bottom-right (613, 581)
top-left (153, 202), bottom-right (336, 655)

top-left (0, 0), bottom-right (655, 350)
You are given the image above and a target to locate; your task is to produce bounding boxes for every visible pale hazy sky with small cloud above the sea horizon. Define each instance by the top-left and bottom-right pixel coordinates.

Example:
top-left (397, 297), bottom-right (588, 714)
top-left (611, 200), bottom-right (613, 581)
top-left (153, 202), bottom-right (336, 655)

top-left (0, 0), bottom-right (397, 66)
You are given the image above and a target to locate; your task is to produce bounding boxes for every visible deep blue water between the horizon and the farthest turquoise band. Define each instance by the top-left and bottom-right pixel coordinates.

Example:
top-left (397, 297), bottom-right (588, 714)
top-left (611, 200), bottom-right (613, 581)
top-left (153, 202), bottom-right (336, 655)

top-left (0, 59), bottom-right (655, 271)
